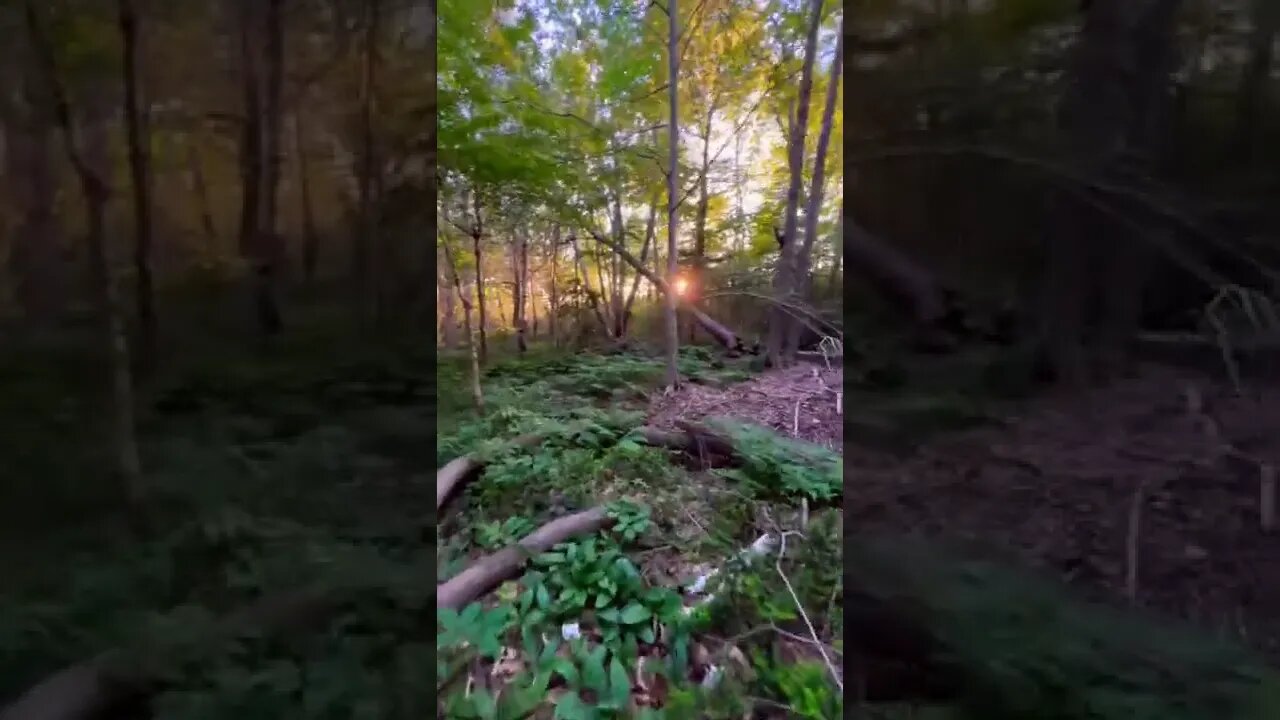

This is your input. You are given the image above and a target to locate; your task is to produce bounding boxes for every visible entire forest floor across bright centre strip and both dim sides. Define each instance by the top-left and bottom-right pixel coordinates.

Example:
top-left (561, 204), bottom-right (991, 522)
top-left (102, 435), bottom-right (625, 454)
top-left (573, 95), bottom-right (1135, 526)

top-left (0, 336), bottom-right (1280, 720)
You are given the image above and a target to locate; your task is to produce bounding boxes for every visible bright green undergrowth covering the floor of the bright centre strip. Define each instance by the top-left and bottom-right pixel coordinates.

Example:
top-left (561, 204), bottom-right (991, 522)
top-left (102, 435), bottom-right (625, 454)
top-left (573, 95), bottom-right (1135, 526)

top-left (436, 348), bottom-right (842, 719)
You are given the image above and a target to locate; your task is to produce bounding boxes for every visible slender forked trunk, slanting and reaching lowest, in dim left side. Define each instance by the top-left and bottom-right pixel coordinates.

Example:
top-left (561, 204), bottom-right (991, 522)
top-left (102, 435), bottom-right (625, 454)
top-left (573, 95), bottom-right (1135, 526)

top-left (24, 0), bottom-right (145, 509)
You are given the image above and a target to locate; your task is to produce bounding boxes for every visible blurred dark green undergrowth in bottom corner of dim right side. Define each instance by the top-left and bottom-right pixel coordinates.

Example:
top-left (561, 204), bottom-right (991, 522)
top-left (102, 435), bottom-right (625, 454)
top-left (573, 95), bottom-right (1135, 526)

top-left (846, 536), bottom-right (1280, 720)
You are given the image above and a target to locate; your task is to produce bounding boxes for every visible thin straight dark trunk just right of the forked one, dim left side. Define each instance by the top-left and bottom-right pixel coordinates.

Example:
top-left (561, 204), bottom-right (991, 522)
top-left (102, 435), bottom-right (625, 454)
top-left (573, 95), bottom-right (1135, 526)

top-left (116, 0), bottom-right (156, 368)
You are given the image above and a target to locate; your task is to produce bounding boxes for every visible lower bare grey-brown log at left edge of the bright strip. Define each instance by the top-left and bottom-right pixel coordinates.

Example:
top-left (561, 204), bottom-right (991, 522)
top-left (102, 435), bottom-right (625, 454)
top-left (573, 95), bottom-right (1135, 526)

top-left (435, 507), bottom-right (612, 610)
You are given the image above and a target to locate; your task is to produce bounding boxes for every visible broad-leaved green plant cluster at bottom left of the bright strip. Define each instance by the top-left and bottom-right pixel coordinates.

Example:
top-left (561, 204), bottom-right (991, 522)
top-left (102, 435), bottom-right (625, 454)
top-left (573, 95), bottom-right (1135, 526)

top-left (436, 502), bottom-right (711, 720)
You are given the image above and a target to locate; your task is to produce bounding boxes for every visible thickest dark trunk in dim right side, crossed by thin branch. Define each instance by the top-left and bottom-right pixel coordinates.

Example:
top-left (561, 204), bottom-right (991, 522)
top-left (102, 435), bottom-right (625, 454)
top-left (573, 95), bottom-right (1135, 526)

top-left (1041, 0), bottom-right (1180, 387)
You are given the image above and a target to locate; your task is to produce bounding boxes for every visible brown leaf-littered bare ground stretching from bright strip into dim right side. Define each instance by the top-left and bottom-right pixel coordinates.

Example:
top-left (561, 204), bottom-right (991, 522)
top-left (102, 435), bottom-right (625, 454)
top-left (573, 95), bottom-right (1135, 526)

top-left (649, 365), bottom-right (1280, 661)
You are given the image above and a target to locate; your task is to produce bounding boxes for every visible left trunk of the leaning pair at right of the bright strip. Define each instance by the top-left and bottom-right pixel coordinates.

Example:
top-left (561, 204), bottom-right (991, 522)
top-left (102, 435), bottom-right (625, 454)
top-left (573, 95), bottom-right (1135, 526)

top-left (767, 0), bottom-right (823, 368)
